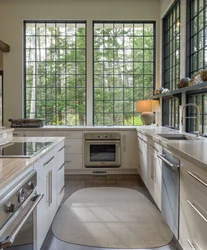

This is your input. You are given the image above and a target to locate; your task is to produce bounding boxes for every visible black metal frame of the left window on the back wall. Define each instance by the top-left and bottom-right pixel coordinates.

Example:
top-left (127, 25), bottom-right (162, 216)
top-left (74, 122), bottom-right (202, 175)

top-left (24, 20), bottom-right (87, 125)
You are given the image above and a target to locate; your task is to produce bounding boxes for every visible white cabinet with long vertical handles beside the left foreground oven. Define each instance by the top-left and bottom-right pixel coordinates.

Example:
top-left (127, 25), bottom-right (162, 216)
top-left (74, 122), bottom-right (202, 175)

top-left (34, 142), bottom-right (64, 250)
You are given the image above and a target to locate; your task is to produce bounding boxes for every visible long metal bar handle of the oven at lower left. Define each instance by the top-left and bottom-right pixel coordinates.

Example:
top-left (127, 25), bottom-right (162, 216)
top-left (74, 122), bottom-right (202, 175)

top-left (0, 194), bottom-right (44, 249)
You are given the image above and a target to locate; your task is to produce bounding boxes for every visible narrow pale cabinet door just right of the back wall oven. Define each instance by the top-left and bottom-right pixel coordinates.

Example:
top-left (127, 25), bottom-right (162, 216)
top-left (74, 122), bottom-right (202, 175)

top-left (121, 131), bottom-right (138, 169)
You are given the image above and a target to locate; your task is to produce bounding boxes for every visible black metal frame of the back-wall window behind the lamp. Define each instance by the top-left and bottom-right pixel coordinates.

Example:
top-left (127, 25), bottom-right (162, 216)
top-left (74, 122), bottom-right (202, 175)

top-left (93, 20), bottom-right (156, 126)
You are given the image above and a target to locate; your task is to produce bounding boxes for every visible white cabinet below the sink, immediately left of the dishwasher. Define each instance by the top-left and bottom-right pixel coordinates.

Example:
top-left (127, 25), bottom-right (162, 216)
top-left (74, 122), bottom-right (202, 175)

top-left (148, 140), bottom-right (162, 210)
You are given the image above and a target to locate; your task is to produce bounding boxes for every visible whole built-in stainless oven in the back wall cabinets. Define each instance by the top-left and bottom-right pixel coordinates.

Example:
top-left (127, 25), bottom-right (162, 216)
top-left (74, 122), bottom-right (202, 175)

top-left (84, 133), bottom-right (121, 168)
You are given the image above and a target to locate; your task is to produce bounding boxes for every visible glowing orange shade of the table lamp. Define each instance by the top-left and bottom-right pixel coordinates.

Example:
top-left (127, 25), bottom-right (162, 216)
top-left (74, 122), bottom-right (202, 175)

top-left (136, 100), bottom-right (160, 112)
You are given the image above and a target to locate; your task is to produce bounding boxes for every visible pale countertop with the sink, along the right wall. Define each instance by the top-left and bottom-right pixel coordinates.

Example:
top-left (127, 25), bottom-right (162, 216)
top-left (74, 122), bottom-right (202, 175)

top-left (137, 127), bottom-right (207, 171)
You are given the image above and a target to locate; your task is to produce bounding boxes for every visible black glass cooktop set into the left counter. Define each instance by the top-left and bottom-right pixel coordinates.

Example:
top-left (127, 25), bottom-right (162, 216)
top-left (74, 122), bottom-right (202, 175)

top-left (0, 142), bottom-right (52, 158)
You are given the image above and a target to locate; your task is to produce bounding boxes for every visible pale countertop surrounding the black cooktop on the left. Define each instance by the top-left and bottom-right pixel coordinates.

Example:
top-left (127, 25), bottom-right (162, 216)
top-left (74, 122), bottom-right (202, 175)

top-left (0, 137), bottom-right (65, 195)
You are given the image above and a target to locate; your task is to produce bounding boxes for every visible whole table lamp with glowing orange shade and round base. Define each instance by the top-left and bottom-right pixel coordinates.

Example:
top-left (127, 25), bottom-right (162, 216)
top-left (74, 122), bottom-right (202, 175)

top-left (136, 100), bottom-right (160, 125)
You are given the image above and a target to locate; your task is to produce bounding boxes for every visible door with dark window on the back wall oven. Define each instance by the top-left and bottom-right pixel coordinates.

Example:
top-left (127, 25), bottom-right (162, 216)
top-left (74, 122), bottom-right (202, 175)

top-left (85, 140), bottom-right (121, 167)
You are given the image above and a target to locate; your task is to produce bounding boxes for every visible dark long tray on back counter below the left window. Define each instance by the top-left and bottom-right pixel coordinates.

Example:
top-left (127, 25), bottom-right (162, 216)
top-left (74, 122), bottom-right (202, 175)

top-left (8, 118), bottom-right (45, 128)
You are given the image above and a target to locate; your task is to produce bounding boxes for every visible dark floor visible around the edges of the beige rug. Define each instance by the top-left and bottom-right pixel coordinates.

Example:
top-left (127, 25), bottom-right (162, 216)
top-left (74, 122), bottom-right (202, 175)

top-left (41, 175), bottom-right (182, 250)
